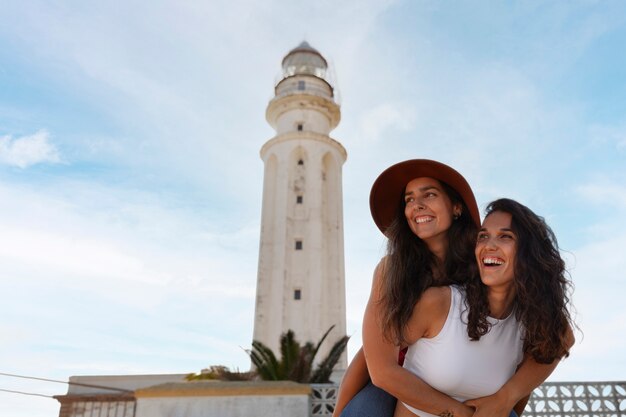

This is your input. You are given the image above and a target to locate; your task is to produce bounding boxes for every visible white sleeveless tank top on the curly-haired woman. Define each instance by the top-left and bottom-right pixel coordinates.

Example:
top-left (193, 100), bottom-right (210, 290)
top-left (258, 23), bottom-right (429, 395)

top-left (404, 286), bottom-right (523, 417)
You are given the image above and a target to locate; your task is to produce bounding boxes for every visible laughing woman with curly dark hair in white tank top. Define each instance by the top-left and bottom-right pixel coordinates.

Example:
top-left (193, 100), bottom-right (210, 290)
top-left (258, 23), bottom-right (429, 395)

top-left (391, 199), bottom-right (573, 417)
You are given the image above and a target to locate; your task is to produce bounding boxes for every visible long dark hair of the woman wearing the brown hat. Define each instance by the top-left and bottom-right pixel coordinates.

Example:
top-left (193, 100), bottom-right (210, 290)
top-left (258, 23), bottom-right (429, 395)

top-left (379, 181), bottom-right (478, 345)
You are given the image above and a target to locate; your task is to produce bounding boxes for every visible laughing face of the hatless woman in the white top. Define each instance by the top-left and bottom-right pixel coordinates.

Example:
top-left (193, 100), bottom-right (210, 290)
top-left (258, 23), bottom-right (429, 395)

top-left (476, 211), bottom-right (517, 290)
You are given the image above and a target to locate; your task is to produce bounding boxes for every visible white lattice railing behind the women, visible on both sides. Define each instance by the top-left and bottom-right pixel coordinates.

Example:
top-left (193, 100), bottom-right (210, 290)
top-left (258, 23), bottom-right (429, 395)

top-left (310, 382), bottom-right (626, 417)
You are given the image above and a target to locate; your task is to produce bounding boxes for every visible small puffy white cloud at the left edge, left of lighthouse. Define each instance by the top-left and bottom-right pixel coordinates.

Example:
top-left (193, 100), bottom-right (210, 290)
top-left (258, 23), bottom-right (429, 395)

top-left (0, 130), bottom-right (61, 168)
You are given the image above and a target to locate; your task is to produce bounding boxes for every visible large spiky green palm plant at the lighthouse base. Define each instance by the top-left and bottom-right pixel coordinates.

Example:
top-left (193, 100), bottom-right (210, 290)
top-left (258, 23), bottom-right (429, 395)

top-left (246, 326), bottom-right (350, 383)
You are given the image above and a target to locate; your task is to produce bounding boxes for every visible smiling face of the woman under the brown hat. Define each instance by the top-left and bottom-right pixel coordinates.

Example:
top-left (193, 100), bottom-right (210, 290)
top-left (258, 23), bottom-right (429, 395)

top-left (404, 177), bottom-right (461, 253)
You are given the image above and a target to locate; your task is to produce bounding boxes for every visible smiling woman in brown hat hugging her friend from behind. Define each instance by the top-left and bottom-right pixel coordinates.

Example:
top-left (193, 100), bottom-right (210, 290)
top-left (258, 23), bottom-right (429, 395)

top-left (333, 159), bottom-right (556, 417)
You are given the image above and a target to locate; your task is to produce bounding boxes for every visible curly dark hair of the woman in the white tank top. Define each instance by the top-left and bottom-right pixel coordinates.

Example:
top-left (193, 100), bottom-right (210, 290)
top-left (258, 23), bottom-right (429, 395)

top-left (465, 198), bottom-right (572, 363)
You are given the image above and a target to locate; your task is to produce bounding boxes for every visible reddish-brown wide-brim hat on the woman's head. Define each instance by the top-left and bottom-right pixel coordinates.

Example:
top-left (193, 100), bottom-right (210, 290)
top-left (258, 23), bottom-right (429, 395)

top-left (370, 159), bottom-right (480, 234)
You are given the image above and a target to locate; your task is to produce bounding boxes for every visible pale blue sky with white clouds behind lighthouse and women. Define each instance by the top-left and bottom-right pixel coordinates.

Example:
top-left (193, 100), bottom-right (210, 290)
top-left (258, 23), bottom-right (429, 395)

top-left (0, 0), bottom-right (626, 417)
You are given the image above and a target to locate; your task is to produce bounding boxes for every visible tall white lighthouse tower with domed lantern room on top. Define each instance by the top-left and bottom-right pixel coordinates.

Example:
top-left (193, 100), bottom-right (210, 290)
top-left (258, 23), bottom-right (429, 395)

top-left (253, 42), bottom-right (347, 370)
